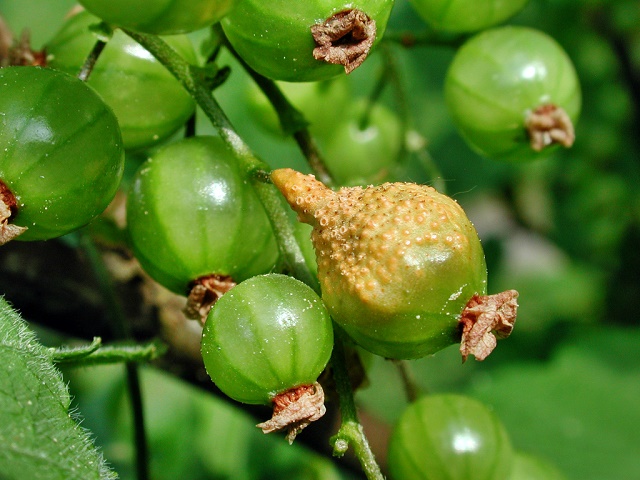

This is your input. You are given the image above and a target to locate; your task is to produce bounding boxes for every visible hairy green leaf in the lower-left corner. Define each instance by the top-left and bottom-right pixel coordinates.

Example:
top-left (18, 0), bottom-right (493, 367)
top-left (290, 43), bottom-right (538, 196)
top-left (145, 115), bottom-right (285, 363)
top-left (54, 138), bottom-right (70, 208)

top-left (0, 297), bottom-right (116, 480)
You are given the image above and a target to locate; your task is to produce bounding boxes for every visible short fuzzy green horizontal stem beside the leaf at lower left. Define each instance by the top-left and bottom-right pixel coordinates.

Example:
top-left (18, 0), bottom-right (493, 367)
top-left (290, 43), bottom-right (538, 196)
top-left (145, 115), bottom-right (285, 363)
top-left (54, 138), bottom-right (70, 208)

top-left (52, 337), bottom-right (166, 367)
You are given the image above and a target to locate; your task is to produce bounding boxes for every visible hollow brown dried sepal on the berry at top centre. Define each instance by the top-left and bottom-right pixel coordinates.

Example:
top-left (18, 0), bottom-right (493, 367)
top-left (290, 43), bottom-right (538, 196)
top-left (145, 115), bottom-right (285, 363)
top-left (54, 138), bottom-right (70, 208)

top-left (311, 9), bottom-right (376, 73)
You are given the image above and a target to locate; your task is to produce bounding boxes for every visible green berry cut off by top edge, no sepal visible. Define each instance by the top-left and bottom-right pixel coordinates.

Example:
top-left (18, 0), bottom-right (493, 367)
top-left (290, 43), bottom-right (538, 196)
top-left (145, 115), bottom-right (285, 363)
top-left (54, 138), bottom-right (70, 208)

top-left (75, 0), bottom-right (235, 35)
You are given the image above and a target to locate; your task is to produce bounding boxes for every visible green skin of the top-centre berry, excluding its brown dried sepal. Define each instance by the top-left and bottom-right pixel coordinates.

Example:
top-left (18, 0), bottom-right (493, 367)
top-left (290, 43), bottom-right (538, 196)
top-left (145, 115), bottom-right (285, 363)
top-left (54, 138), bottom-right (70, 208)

top-left (220, 0), bottom-right (393, 82)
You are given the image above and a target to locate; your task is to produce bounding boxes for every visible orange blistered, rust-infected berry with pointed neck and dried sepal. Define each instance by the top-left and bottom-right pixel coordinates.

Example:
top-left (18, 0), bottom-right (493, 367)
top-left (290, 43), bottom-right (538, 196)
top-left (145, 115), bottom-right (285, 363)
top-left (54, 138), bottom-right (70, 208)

top-left (271, 169), bottom-right (518, 360)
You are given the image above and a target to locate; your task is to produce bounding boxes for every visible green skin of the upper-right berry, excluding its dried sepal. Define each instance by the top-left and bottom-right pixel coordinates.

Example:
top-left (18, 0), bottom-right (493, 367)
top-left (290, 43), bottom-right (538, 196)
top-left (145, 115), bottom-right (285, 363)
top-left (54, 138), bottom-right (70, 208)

top-left (445, 26), bottom-right (581, 161)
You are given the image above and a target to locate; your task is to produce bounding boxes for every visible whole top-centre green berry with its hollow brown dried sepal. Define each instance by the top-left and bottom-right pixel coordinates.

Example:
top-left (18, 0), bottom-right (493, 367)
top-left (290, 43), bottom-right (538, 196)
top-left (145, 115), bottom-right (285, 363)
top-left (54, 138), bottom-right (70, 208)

top-left (220, 0), bottom-right (394, 82)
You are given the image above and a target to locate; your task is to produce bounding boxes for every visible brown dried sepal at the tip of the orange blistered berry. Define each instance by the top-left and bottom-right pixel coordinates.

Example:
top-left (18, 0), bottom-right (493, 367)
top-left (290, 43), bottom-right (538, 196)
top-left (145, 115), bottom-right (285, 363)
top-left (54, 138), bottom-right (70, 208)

top-left (460, 290), bottom-right (518, 362)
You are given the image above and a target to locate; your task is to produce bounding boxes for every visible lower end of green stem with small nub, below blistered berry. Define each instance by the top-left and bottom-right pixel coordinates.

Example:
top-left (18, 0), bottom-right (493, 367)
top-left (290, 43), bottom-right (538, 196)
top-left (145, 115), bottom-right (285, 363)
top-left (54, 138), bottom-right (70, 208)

top-left (331, 324), bottom-right (384, 480)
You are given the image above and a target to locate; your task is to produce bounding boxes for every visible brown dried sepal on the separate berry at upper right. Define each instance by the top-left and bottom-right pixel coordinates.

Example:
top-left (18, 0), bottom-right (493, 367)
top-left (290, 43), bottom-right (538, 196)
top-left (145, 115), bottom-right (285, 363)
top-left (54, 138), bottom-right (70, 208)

top-left (526, 104), bottom-right (576, 152)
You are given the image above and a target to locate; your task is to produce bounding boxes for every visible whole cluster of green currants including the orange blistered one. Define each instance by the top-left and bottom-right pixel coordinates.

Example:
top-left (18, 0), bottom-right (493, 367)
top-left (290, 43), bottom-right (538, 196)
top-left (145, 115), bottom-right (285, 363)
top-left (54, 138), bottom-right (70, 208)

top-left (0, 0), bottom-right (581, 480)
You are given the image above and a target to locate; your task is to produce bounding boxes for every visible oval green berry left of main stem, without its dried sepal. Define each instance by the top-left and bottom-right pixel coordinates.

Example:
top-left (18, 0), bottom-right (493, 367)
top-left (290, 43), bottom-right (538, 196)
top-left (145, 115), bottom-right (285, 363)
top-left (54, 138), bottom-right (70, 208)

top-left (127, 137), bottom-right (278, 295)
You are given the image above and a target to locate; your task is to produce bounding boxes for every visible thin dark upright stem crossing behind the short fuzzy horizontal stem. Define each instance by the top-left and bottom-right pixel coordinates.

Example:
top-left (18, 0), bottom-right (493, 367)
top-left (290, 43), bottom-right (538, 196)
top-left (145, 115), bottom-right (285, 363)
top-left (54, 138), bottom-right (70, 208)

top-left (80, 233), bottom-right (150, 480)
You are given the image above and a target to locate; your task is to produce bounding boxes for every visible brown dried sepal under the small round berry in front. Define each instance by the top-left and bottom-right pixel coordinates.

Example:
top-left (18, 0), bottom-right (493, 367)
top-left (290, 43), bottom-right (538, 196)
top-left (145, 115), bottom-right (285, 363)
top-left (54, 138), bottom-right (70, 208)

top-left (256, 382), bottom-right (327, 444)
